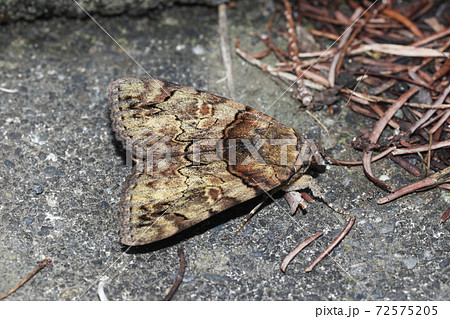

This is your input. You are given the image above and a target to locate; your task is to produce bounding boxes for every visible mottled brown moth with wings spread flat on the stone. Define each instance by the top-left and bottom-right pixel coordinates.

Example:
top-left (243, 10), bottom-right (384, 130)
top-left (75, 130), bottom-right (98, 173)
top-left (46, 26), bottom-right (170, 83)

top-left (109, 78), bottom-right (322, 246)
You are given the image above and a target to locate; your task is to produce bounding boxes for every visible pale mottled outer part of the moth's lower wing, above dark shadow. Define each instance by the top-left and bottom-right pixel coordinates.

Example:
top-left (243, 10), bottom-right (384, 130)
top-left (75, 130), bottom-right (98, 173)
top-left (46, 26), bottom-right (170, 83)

top-left (120, 158), bottom-right (259, 245)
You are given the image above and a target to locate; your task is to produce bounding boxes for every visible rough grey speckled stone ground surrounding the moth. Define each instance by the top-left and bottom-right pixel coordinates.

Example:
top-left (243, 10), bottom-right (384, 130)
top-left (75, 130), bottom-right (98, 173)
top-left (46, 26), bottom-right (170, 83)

top-left (0, 1), bottom-right (450, 300)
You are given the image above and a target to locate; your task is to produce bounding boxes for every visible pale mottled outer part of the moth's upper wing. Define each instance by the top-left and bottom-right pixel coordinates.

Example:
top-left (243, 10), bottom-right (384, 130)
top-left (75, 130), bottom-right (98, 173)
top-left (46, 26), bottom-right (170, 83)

top-left (109, 78), bottom-right (245, 158)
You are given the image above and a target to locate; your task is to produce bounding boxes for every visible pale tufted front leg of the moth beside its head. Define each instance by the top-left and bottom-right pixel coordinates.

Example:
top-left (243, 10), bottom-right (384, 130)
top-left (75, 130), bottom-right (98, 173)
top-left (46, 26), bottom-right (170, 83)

top-left (283, 174), bottom-right (348, 215)
